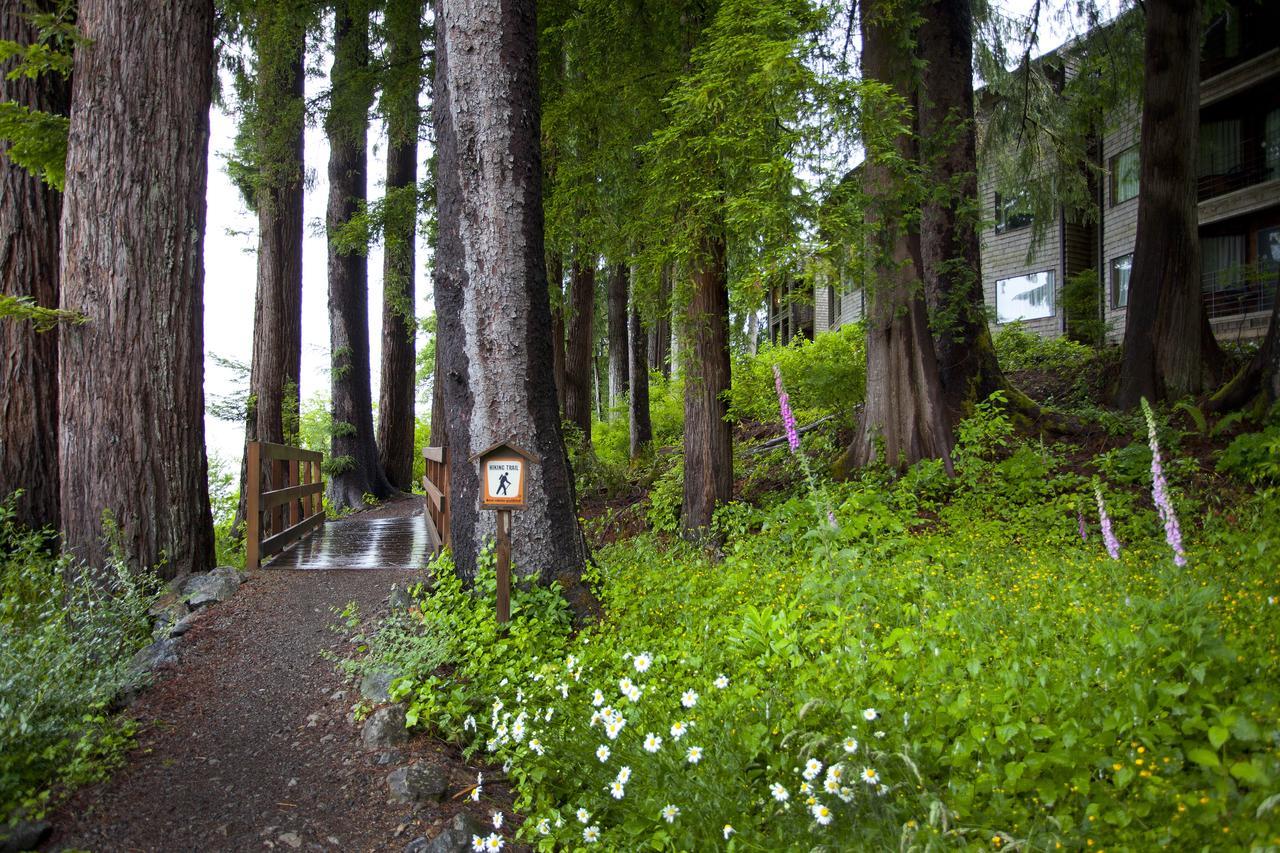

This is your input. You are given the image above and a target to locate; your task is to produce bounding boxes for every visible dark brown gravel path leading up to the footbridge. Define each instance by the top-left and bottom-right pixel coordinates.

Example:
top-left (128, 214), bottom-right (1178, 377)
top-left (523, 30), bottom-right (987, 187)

top-left (45, 499), bottom-right (511, 852)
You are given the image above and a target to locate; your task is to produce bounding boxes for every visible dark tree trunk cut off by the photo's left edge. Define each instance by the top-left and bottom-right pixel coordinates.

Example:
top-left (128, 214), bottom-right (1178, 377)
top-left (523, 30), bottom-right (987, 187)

top-left (0, 0), bottom-right (70, 528)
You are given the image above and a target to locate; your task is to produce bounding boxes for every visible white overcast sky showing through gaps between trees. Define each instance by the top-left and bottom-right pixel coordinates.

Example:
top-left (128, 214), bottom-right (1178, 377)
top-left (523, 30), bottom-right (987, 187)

top-left (194, 0), bottom-right (1119, 470)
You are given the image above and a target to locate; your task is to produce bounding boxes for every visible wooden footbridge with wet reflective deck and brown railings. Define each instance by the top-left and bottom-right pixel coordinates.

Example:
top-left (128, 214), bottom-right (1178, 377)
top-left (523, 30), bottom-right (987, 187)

top-left (244, 442), bottom-right (449, 570)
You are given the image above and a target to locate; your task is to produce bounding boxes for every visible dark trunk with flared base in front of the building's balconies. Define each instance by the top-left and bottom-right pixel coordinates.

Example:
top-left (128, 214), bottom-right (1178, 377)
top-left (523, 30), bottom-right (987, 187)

top-left (1116, 0), bottom-right (1221, 407)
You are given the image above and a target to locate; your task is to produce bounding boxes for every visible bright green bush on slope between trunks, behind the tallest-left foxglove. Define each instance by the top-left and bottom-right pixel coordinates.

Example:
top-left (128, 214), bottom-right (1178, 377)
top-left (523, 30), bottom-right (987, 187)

top-left (730, 323), bottom-right (867, 424)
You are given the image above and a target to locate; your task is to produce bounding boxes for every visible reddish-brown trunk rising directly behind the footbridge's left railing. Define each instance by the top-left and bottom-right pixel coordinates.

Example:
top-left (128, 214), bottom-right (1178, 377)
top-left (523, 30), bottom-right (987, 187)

top-left (233, 3), bottom-right (307, 529)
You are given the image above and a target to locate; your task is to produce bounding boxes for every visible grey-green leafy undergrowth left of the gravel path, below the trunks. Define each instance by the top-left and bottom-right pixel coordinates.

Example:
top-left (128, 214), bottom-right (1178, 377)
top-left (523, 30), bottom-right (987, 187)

top-left (0, 500), bottom-right (157, 825)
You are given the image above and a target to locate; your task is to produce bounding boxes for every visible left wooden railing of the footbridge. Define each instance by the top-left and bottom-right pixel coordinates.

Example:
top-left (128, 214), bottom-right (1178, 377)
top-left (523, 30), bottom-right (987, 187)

top-left (244, 442), bottom-right (324, 569)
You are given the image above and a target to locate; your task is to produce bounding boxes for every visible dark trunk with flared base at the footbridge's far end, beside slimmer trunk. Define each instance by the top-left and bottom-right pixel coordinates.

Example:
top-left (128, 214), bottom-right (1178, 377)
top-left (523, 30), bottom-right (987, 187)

top-left (325, 0), bottom-right (393, 510)
